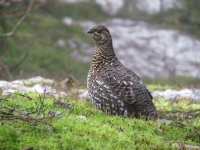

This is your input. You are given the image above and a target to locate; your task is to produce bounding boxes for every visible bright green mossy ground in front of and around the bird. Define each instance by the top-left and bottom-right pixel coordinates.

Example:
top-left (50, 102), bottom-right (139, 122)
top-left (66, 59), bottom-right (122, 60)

top-left (0, 87), bottom-right (200, 150)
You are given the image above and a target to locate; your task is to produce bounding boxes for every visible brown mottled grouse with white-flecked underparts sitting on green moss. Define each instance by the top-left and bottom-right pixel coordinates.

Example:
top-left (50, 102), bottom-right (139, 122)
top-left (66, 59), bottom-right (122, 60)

top-left (87, 25), bottom-right (157, 119)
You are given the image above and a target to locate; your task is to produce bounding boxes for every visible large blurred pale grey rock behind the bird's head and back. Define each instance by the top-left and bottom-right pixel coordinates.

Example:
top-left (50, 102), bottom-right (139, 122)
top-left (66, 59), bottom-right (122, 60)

top-left (63, 18), bottom-right (200, 78)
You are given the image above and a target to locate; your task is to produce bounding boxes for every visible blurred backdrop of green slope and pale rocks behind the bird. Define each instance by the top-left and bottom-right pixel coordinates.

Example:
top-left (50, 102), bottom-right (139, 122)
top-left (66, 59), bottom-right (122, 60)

top-left (0, 0), bottom-right (200, 87)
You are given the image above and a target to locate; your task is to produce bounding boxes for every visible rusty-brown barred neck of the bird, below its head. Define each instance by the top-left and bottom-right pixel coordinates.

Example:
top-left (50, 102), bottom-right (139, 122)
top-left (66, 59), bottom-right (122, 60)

top-left (91, 42), bottom-right (118, 69)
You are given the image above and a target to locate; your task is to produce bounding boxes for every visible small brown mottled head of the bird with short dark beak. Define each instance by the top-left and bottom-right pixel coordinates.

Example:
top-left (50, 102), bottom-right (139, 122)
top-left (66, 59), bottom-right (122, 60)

top-left (87, 25), bottom-right (112, 45)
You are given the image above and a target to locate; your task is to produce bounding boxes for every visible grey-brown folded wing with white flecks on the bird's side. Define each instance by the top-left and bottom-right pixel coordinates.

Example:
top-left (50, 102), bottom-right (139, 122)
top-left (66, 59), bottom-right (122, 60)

top-left (102, 68), bottom-right (152, 105)
